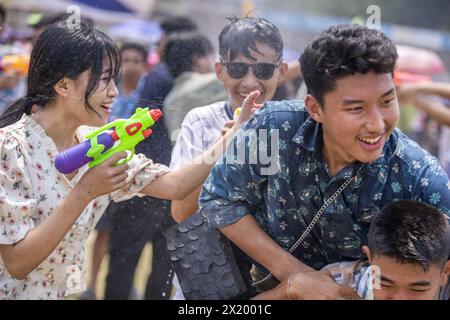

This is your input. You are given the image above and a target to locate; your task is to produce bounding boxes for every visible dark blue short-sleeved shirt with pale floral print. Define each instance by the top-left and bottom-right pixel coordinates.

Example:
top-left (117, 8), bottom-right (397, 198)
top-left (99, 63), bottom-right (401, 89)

top-left (200, 101), bottom-right (450, 270)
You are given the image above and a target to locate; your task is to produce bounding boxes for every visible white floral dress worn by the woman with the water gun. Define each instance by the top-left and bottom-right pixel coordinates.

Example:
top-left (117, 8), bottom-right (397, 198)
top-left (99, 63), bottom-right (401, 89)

top-left (0, 115), bottom-right (168, 299)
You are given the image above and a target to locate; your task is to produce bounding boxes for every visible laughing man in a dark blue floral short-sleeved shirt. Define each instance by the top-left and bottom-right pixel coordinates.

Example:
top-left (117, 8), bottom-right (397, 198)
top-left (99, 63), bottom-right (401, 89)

top-left (200, 25), bottom-right (450, 299)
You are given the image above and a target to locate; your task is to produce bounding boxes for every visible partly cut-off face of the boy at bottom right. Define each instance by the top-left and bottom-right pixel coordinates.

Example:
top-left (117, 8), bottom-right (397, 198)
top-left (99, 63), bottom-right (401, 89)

top-left (370, 252), bottom-right (448, 300)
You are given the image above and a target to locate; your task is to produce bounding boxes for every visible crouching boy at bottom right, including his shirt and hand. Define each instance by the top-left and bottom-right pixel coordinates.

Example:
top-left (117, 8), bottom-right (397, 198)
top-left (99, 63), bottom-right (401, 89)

top-left (258, 200), bottom-right (450, 300)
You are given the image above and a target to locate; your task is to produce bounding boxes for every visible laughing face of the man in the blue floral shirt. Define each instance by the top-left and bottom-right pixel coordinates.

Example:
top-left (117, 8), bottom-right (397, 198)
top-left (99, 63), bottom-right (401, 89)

top-left (306, 72), bottom-right (399, 174)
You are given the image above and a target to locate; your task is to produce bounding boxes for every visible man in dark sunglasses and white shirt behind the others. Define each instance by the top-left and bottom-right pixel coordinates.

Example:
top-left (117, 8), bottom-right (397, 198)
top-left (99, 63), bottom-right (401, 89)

top-left (170, 17), bottom-right (288, 299)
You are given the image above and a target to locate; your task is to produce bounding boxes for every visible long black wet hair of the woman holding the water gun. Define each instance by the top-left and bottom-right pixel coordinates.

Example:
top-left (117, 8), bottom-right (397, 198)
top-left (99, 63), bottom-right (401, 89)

top-left (0, 18), bottom-right (120, 128)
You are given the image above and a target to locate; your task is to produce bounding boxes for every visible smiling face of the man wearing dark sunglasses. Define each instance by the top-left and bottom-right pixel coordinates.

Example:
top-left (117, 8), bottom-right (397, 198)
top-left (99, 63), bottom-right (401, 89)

top-left (215, 43), bottom-right (287, 109)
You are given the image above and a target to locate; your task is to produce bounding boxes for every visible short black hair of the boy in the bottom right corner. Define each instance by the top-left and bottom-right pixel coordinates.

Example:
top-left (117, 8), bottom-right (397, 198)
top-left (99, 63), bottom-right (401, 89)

top-left (368, 200), bottom-right (450, 272)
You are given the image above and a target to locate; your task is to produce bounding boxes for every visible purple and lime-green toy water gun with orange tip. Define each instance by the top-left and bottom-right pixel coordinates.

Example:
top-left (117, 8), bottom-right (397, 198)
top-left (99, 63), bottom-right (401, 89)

top-left (55, 108), bottom-right (162, 174)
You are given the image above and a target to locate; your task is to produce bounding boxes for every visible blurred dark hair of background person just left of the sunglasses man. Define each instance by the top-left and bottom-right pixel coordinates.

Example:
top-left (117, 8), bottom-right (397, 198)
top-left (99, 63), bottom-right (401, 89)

top-left (164, 32), bottom-right (213, 78)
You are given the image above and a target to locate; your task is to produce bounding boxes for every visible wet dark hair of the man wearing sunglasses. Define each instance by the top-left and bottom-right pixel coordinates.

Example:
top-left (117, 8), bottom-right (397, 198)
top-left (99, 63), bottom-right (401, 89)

top-left (219, 17), bottom-right (283, 61)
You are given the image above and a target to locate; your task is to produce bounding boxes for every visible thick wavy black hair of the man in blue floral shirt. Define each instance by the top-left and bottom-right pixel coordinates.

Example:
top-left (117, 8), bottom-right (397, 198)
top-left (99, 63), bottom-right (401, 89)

top-left (300, 25), bottom-right (398, 106)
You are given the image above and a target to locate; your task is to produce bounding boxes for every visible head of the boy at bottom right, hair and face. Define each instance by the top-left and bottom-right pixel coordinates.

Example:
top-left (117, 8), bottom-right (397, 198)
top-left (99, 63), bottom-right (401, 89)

top-left (363, 200), bottom-right (450, 300)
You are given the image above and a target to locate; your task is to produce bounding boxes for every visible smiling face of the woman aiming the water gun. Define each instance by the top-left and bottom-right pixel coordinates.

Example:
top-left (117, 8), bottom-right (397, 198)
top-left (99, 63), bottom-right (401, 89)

top-left (67, 59), bottom-right (119, 127)
